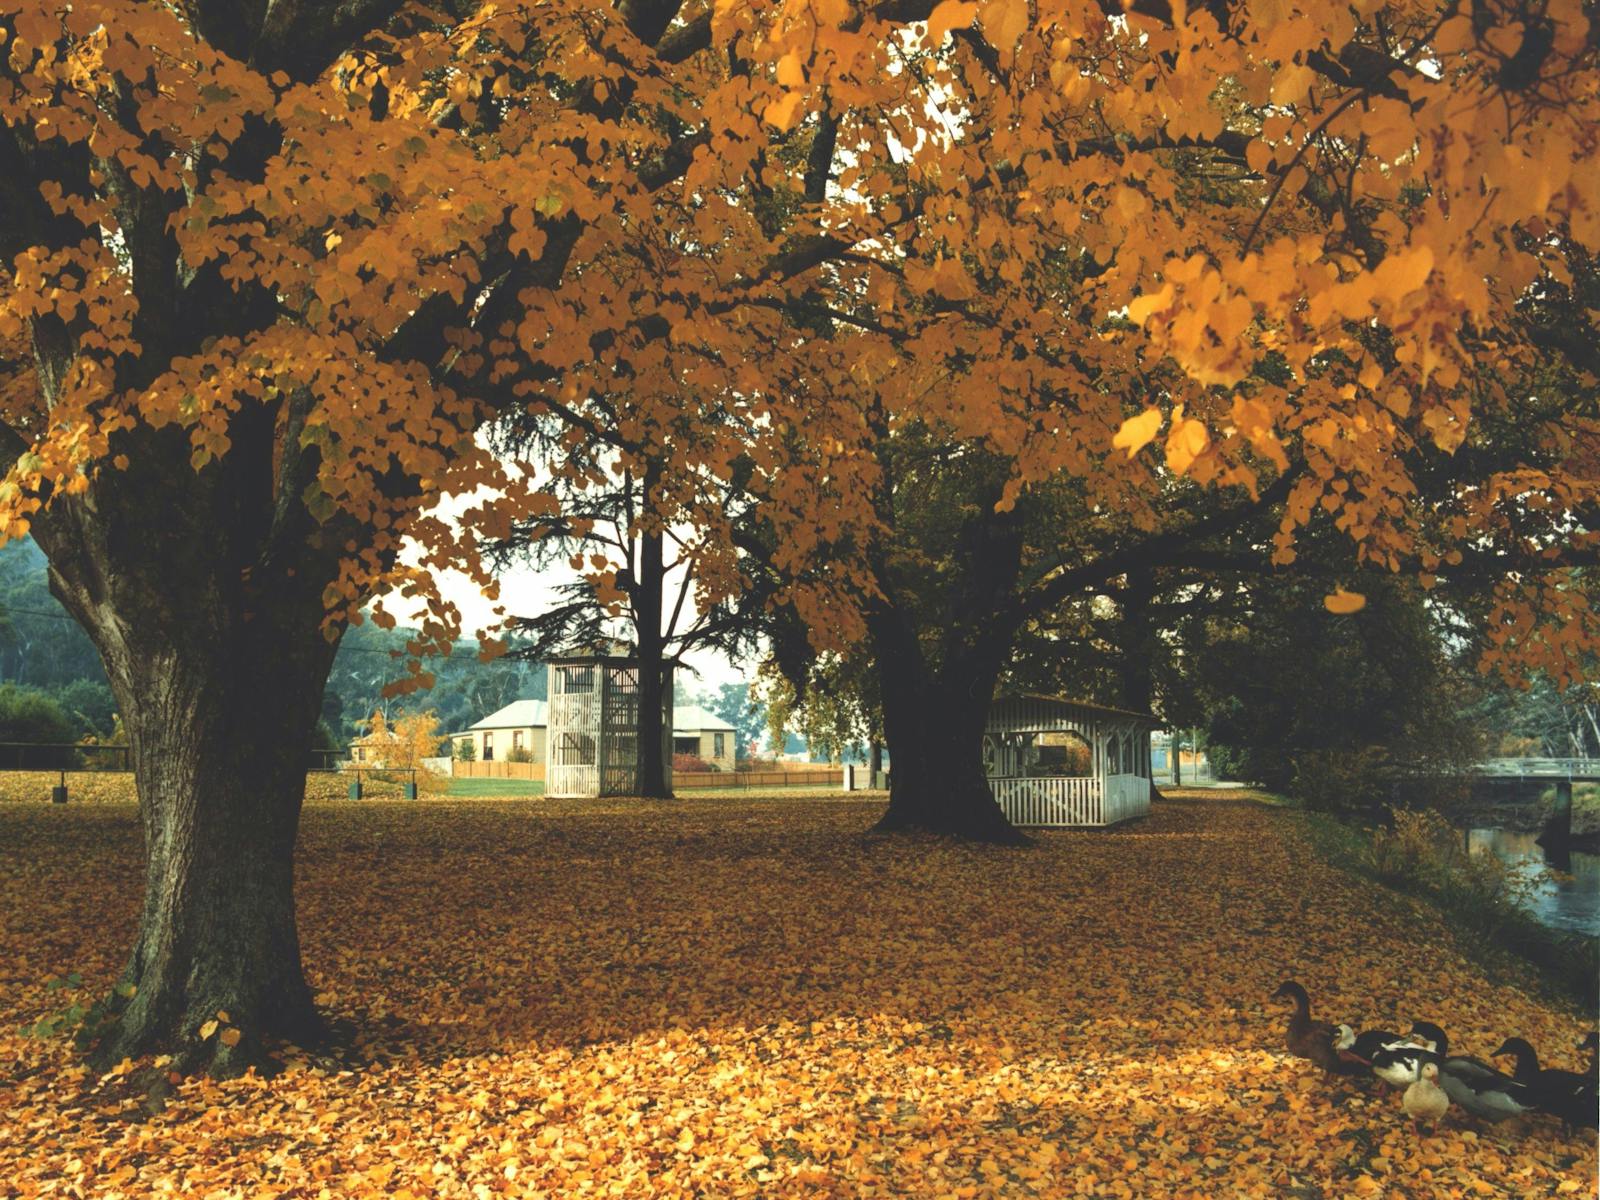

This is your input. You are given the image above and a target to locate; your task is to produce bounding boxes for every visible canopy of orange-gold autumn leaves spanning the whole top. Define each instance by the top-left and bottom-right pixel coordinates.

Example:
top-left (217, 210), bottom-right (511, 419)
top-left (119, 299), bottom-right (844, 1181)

top-left (0, 0), bottom-right (1600, 683)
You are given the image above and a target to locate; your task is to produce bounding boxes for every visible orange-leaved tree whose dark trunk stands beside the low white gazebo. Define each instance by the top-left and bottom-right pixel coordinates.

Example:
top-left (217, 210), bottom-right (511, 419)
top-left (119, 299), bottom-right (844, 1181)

top-left (716, 3), bottom-right (1600, 838)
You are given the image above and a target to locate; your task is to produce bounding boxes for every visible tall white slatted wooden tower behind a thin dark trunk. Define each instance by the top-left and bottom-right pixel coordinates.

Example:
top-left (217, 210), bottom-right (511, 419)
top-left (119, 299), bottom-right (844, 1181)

top-left (544, 654), bottom-right (672, 798)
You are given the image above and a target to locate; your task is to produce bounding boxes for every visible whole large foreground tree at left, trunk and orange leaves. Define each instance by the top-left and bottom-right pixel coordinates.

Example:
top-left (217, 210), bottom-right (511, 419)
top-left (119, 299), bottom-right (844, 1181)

top-left (0, 0), bottom-right (851, 1070)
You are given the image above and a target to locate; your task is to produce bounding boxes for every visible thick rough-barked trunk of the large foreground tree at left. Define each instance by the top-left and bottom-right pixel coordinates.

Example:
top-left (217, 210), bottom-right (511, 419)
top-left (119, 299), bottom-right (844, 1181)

top-left (34, 411), bottom-right (353, 1074)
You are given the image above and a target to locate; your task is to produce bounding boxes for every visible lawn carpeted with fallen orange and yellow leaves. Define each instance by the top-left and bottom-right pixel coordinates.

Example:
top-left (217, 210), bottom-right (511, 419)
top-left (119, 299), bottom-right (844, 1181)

top-left (0, 797), bottom-right (1595, 1200)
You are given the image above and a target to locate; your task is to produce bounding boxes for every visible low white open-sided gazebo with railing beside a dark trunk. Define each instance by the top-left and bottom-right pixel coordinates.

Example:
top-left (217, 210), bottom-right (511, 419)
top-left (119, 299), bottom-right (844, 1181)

top-left (984, 694), bottom-right (1155, 827)
